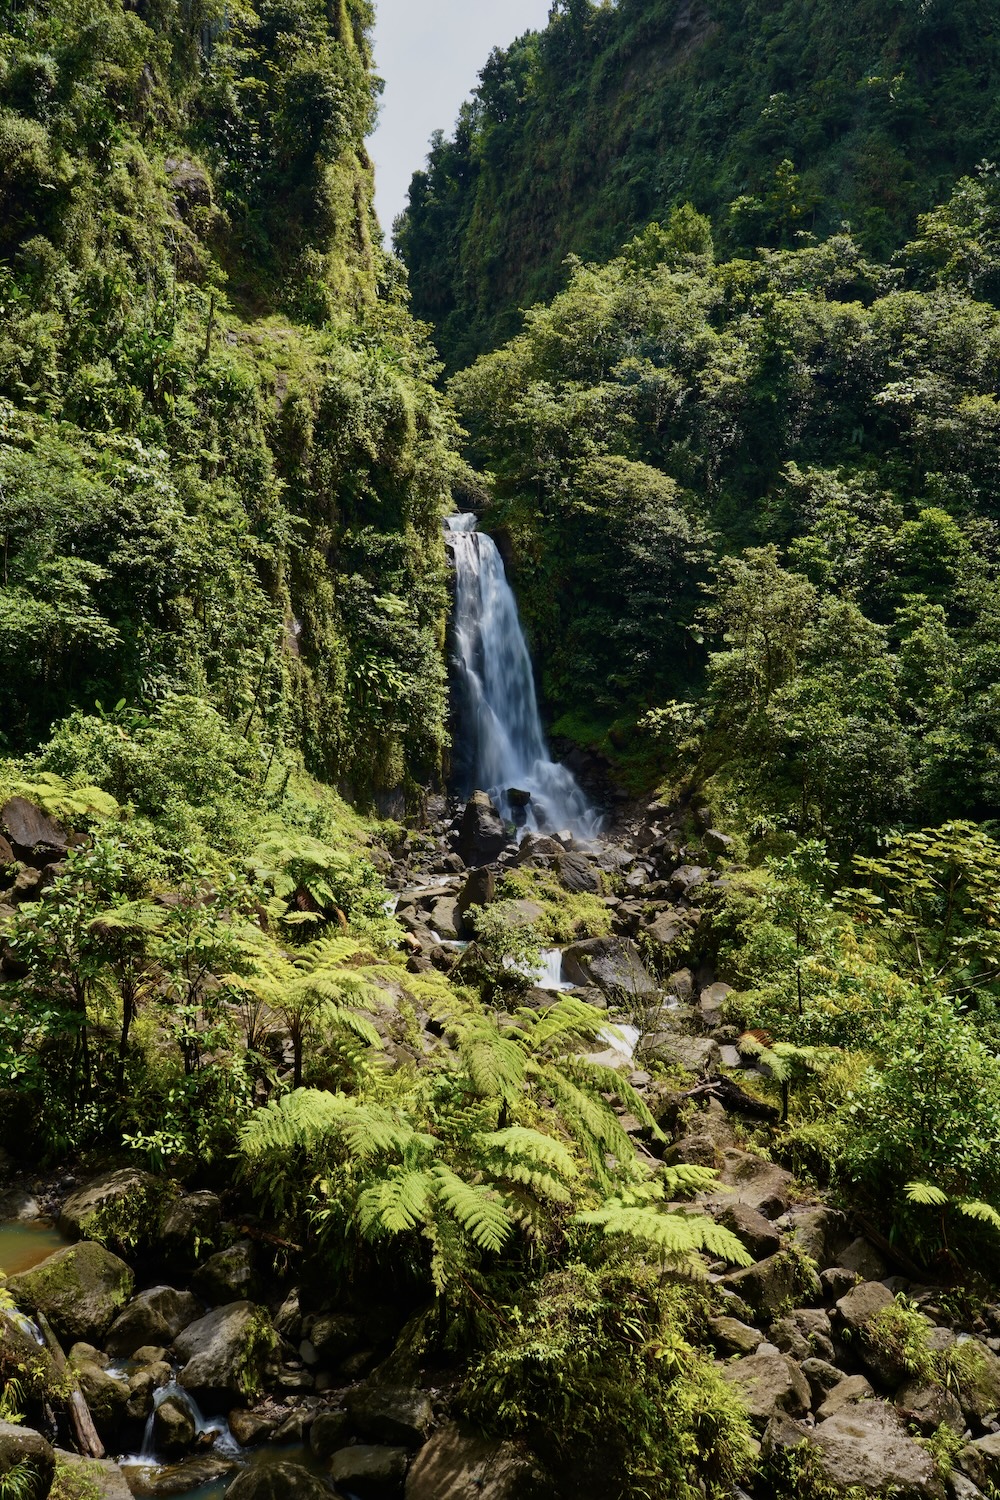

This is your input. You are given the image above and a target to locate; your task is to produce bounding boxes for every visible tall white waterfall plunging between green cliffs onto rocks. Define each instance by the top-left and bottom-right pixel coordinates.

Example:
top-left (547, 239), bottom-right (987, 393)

top-left (447, 513), bottom-right (600, 839)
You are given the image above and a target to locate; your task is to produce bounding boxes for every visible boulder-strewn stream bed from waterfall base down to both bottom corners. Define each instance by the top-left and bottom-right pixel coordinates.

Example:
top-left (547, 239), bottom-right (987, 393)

top-left (0, 794), bottom-right (1000, 1500)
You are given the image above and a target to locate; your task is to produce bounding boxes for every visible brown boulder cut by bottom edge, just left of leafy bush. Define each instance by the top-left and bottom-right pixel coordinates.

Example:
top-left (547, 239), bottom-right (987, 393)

top-left (406, 1422), bottom-right (555, 1500)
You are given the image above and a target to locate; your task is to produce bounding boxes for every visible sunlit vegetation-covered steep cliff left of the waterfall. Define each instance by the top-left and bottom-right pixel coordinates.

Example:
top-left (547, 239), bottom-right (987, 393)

top-left (0, 0), bottom-right (453, 795)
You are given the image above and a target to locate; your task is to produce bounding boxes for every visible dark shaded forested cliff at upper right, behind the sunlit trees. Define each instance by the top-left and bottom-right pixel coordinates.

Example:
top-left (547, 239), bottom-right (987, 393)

top-left (397, 0), bottom-right (1000, 368)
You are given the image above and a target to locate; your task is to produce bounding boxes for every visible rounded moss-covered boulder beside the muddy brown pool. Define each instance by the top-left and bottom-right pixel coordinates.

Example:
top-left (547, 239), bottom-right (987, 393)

top-left (7, 1244), bottom-right (135, 1343)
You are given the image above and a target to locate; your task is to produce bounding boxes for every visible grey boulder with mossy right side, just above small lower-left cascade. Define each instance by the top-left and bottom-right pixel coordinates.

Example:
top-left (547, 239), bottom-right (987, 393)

top-left (174, 1302), bottom-right (276, 1404)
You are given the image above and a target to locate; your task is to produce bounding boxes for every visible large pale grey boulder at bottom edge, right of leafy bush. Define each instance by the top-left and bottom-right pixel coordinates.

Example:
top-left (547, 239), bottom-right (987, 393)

top-left (763, 1401), bottom-right (945, 1500)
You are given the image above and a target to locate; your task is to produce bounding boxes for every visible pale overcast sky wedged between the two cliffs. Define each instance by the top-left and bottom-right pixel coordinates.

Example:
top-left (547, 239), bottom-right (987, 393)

top-left (369, 0), bottom-right (549, 240)
